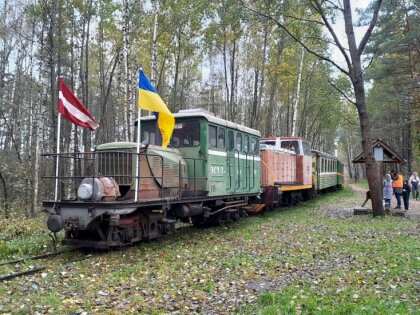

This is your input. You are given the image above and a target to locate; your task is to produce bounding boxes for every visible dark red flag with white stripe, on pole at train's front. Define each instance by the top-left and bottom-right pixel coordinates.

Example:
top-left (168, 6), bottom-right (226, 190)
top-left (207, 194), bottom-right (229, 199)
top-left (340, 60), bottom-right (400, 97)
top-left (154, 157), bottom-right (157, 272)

top-left (58, 78), bottom-right (99, 131)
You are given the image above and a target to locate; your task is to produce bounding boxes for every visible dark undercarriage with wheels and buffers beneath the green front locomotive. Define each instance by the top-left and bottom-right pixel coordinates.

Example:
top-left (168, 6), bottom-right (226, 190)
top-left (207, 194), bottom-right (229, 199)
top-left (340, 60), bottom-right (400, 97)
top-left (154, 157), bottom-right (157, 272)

top-left (49, 196), bottom-right (255, 249)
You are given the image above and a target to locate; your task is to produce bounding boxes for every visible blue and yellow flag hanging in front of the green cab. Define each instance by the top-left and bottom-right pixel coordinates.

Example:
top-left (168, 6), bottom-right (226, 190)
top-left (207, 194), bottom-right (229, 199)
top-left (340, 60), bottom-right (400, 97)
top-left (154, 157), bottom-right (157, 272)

top-left (139, 69), bottom-right (175, 148)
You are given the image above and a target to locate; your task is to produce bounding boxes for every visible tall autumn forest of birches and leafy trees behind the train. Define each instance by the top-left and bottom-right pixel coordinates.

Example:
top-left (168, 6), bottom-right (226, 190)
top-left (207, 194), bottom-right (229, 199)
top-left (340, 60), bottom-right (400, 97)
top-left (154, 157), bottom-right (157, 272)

top-left (0, 0), bottom-right (420, 216)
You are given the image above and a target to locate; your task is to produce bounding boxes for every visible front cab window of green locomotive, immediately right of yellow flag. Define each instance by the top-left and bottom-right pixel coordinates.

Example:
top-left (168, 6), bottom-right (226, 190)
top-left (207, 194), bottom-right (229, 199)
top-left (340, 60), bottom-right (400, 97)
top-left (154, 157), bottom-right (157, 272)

top-left (172, 121), bottom-right (200, 148)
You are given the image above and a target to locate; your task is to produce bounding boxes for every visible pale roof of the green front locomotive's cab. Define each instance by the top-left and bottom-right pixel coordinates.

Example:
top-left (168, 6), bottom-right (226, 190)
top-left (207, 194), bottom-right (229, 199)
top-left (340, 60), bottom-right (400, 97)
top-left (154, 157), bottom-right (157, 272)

top-left (141, 108), bottom-right (261, 137)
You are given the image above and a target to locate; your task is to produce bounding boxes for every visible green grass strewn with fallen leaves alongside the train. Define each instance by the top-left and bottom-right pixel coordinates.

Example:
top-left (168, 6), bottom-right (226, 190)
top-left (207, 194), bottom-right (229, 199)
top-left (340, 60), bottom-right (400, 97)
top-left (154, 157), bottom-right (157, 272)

top-left (0, 189), bottom-right (420, 314)
